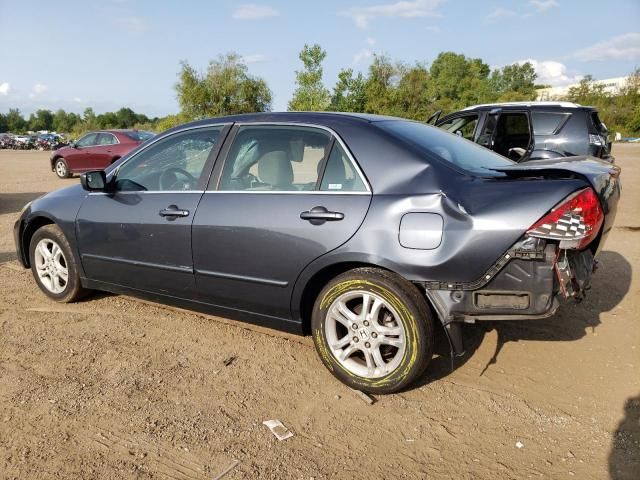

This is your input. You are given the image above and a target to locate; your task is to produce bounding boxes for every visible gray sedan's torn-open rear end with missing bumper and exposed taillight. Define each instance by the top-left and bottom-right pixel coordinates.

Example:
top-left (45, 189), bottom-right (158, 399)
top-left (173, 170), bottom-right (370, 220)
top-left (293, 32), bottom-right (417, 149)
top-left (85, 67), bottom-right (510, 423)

top-left (421, 159), bottom-right (620, 355)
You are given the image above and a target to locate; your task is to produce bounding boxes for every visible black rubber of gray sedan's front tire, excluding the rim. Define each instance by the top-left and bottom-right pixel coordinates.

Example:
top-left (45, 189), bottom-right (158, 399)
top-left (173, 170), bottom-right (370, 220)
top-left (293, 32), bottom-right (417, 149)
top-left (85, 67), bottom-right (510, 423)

top-left (29, 225), bottom-right (81, 302)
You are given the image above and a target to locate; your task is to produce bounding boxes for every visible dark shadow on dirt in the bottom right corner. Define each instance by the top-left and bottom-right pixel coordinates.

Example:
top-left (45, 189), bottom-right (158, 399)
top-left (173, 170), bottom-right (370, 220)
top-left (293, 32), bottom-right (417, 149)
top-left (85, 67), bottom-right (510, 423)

top-left (609, 395), bottom-right (640, 480)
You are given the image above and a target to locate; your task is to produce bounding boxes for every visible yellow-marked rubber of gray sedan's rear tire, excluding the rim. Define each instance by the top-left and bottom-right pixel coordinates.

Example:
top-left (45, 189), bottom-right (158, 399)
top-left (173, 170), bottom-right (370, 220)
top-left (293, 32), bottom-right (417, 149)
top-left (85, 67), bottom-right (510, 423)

top-left (311, 274), bottom-right (433, 393)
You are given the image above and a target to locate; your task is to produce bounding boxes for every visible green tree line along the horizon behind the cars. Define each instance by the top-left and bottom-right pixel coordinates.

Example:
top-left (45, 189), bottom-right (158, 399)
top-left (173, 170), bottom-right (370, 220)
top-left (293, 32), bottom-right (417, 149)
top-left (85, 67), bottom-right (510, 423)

top-left (0, 44), bottom-right (640, 135)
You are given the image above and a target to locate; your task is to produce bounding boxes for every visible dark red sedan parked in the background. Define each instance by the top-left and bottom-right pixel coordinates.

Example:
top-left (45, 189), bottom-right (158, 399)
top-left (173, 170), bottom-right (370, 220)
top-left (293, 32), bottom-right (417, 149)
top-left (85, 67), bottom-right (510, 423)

top-left (51, 130), bottom-right (154, 178)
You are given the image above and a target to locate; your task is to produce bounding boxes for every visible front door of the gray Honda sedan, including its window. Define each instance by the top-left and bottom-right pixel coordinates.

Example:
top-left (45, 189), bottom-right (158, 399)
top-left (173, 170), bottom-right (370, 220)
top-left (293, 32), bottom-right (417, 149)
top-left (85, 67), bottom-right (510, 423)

top-left (76, 126), bottom-right (229, 298)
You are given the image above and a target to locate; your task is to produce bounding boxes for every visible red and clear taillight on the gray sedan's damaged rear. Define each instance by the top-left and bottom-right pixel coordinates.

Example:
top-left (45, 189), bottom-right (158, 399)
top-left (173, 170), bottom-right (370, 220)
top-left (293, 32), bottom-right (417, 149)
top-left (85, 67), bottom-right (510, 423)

top-left (527, 188), bottom-right (604, 249)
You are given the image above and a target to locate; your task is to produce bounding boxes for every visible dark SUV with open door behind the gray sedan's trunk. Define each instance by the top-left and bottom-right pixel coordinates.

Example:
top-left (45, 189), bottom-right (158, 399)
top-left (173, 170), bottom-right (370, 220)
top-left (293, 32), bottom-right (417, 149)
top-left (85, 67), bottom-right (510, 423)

top-left (436, 102), bottom-right (613, 162)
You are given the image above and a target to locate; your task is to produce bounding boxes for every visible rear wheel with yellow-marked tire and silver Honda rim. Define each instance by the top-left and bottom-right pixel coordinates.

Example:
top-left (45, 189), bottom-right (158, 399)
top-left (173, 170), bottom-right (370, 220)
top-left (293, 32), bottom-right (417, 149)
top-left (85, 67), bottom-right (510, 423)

top-left (311, 268), bottom-right (435, 394)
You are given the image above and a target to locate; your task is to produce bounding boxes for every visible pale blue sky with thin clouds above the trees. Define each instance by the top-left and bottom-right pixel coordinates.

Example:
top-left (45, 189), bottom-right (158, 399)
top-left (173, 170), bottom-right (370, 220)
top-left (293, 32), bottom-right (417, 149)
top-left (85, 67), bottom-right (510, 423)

top-left (0, 0), bottom-right (640, 116)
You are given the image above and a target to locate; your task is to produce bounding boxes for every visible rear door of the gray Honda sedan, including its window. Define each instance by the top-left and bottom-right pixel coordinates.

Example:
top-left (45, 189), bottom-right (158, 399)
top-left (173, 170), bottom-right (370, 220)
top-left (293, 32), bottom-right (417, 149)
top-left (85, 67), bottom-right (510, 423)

top-left (193, 124), bottom-right (371, 318)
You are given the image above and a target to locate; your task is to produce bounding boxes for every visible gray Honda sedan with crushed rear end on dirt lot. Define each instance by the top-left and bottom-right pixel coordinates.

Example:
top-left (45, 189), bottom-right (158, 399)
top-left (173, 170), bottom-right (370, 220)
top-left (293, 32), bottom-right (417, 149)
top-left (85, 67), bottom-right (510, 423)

top-left (15, 113), bottom-right (620, 393)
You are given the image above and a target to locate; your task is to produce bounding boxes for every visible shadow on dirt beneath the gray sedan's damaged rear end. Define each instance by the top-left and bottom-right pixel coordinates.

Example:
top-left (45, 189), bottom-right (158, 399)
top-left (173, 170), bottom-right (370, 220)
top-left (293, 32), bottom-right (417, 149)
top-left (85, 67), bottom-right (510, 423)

top-left (418, 252), bottom-right (640, 386)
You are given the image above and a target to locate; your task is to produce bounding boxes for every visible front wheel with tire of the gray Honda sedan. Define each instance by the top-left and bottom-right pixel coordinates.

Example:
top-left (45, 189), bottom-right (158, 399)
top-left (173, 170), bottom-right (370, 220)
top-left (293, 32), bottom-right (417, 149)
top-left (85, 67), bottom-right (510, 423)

top-left (29, 225), bottom-right (87, 303)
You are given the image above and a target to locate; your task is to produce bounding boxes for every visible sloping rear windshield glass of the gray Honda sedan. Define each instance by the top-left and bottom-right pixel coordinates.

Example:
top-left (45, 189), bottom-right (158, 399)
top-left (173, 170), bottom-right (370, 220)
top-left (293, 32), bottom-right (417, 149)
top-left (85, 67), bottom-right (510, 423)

top-left (376, 120), bottom-right (515, 175)
